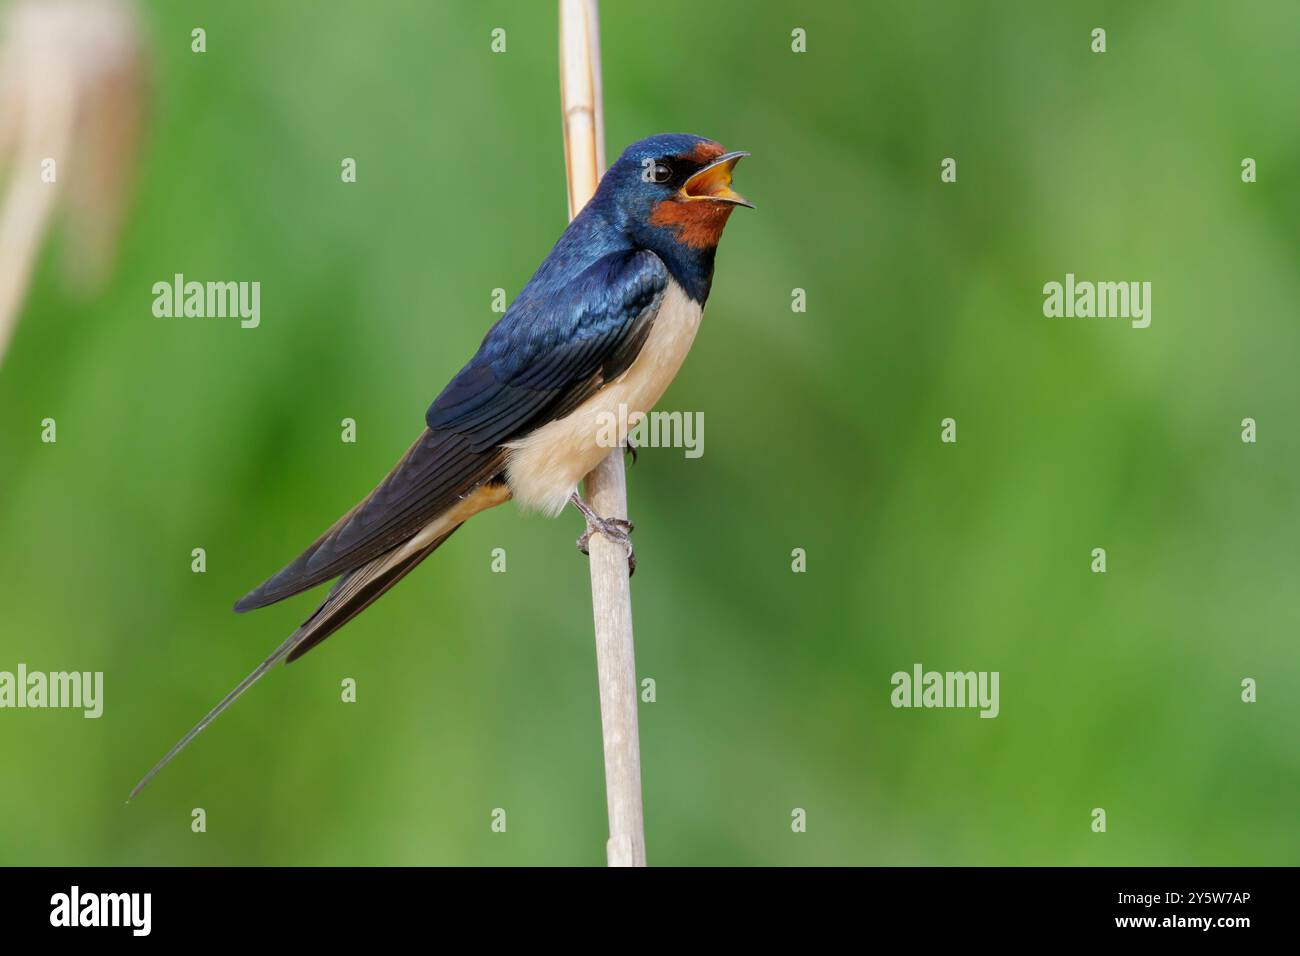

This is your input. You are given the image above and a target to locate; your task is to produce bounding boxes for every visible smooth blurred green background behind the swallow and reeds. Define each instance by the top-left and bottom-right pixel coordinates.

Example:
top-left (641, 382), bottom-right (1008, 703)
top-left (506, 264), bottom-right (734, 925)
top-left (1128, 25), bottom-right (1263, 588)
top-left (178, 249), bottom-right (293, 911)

top-left (0, 0), bottom-right (1300, 865)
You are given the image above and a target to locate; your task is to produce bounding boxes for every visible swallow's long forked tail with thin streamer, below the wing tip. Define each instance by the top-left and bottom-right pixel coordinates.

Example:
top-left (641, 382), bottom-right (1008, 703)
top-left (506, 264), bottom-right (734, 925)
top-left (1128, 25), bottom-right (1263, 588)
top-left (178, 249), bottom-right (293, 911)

top-left (126, 522), bottom-right (460, 803)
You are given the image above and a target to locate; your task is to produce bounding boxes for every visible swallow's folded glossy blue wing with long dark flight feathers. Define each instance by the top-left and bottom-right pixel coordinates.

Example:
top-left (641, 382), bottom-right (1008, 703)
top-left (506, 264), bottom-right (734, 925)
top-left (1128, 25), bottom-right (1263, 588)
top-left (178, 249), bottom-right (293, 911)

top-left (235, 243), bottom-right (668, 611)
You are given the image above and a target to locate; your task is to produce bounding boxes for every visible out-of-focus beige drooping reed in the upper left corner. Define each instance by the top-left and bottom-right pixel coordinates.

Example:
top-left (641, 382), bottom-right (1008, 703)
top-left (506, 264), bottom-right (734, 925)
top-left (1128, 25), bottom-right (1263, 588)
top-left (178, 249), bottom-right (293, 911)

top-left (0, 0), bottom-right (146, 360)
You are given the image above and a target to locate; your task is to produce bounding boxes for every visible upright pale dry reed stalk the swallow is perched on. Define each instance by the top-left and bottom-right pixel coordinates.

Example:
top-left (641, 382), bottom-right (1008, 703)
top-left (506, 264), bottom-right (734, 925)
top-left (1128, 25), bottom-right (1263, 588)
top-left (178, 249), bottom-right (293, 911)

top-left (560, 0), bottom-right (646, 866)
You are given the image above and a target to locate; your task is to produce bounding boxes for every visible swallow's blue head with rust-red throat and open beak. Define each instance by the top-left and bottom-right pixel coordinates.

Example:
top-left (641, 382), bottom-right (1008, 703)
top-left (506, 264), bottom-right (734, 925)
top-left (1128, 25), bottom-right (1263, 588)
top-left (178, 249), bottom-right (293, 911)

top-left (597, 133), bottom-right (753, 254)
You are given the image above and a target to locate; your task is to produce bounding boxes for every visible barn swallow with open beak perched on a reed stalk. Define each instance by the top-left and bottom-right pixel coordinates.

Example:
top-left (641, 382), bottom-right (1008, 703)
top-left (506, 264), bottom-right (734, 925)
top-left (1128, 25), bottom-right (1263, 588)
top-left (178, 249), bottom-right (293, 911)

top-left (127, 133), bottom-right (753, 801)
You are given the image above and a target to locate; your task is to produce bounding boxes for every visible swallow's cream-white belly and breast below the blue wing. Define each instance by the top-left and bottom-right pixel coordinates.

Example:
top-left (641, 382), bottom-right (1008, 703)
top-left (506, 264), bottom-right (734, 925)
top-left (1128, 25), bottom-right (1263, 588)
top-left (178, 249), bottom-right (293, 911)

top-left (506, 278), bottom-right (702, 515)
